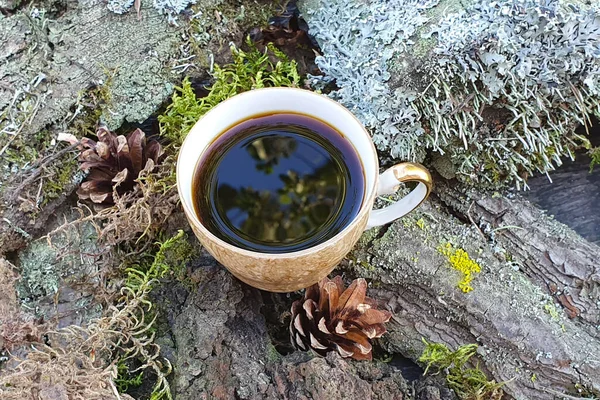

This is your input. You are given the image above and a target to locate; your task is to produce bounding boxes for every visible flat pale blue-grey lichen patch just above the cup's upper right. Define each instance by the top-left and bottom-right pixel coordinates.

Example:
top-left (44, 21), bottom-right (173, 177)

top-left (303, 0), bottom-right (437, 159)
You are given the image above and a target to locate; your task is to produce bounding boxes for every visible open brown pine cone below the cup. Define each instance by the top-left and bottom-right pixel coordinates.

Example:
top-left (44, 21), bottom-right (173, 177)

top-left (290, 276), bottom-right (392, 360)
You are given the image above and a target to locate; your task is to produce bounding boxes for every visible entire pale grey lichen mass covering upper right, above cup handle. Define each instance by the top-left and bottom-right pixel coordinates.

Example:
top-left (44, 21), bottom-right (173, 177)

top-left (304, 0), bottom-right (600, 187)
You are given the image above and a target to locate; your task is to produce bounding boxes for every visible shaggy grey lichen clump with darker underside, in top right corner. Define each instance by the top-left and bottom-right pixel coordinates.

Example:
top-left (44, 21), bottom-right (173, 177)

top-left (417, 0), bottom-right (600, 186)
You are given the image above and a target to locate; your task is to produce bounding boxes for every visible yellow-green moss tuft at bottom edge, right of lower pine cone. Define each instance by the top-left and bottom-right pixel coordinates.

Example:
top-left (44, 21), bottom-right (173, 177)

top-left (419, 339), bottom-right (503, 400)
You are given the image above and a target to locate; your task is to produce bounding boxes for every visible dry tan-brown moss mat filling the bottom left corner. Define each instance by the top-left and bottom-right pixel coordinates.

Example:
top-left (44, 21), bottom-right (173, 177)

top-left (0, 281), bottom-right (171, 400)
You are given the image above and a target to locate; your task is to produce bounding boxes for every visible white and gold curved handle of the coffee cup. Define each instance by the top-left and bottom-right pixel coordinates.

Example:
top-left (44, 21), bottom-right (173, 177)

top-left (365, 162), bottom-right (433, 229)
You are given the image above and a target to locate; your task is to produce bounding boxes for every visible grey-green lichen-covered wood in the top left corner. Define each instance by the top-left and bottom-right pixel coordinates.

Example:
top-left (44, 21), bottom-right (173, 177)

top-left (0, 0), bottom-right (182, 251)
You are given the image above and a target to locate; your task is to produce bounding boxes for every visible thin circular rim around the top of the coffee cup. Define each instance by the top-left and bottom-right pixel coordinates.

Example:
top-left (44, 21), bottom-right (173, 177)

top-left (175, 87), bottom-right (379, 259)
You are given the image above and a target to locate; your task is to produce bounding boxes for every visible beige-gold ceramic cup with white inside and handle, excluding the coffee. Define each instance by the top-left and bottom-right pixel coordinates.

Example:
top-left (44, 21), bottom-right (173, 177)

top-left (177, 88), bottom-right (432, 292)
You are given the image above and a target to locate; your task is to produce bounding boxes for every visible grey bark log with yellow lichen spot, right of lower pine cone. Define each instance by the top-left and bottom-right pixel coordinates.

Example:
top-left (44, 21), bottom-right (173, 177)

top-left (347, 179), bottom-right (600, 399)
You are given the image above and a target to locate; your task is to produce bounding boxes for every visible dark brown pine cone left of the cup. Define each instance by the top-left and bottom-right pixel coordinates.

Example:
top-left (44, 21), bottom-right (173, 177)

top-left (77, 126), bottom-right (163, 204)
